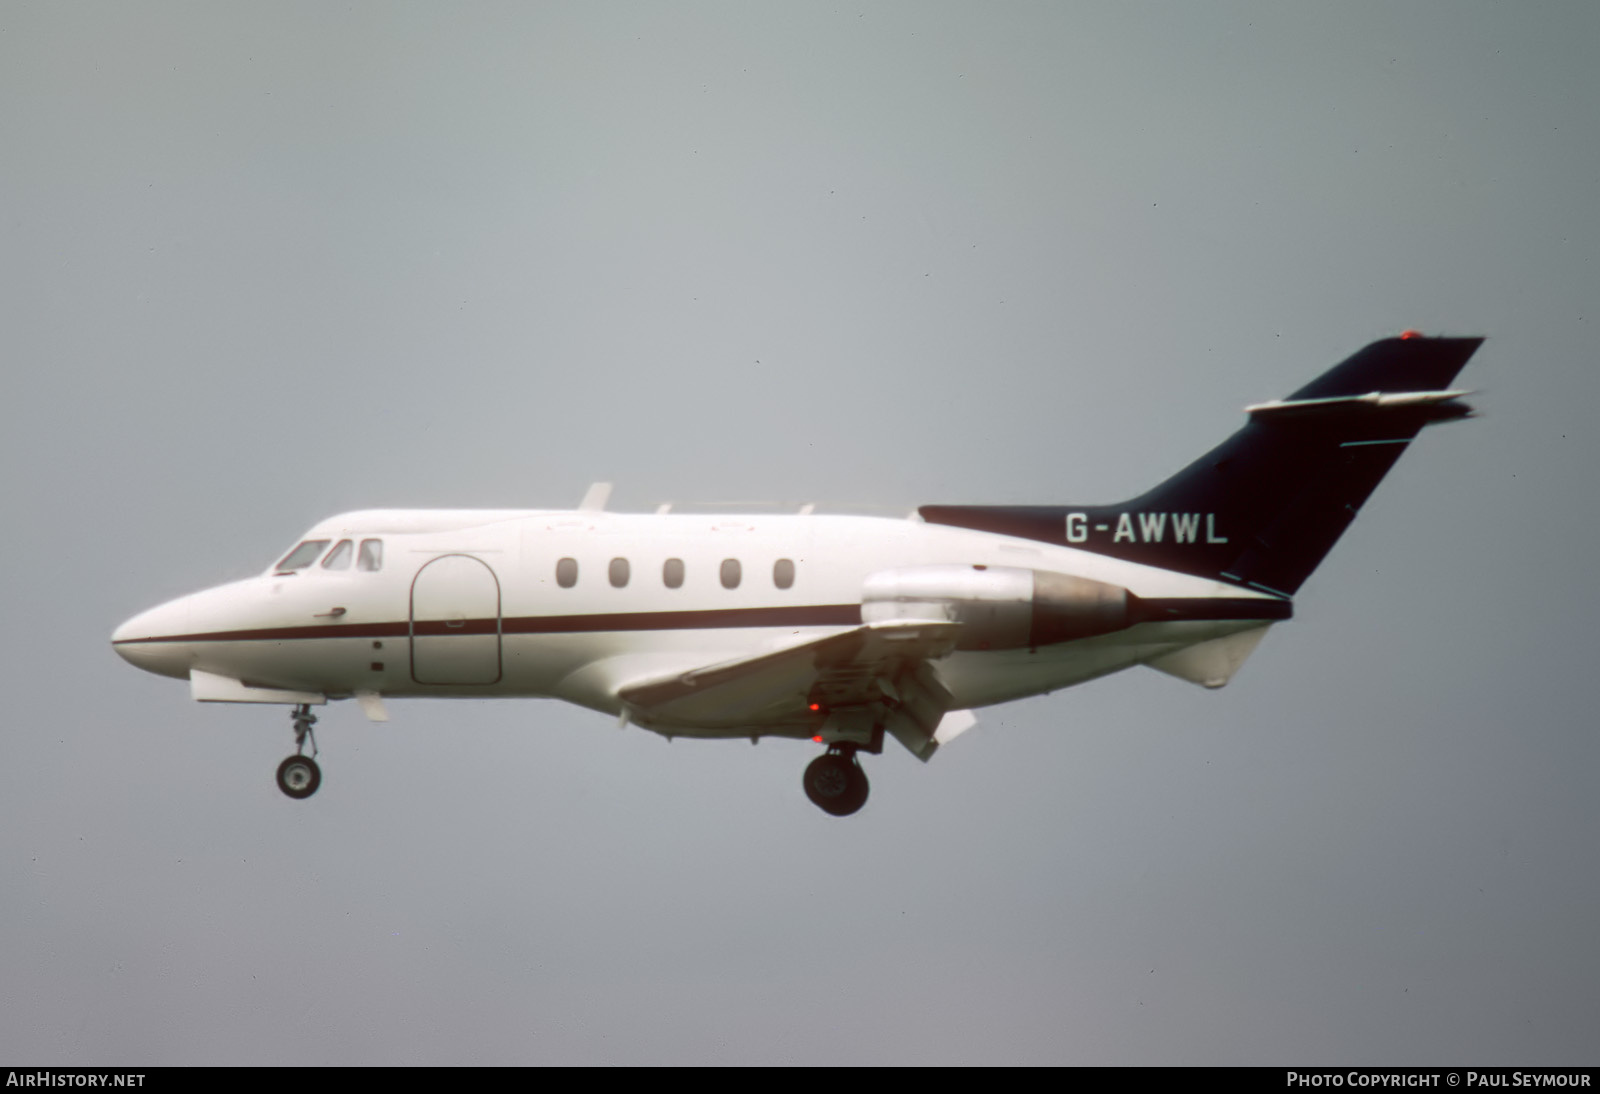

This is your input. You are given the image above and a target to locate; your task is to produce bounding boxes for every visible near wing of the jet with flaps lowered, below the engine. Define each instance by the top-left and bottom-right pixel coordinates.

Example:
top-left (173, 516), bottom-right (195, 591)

top-left (621, 621), bottom-right (971, 760)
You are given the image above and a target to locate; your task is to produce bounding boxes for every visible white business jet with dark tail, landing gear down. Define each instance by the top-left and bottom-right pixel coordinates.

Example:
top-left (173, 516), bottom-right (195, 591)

top-left (112, 331), bottom-right (1483, 816)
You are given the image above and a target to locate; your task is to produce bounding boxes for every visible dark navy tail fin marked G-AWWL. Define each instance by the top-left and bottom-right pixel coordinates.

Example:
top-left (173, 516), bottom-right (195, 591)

top-left (918, 331), bottom-right (1483, 597)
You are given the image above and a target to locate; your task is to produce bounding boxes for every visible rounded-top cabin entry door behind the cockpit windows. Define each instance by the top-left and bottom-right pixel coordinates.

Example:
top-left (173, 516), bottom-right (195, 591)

top-left (411, 555), bottom-right (501, 685)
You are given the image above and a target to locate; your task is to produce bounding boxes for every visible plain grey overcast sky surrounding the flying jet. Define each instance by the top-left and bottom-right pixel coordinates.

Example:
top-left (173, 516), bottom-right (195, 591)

top-left (0, 0), bottom-right (1600, 1065)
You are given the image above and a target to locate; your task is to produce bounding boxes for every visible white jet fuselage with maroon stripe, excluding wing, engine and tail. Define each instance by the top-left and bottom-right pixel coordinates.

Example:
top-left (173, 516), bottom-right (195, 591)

top-left (114, 510), bottom-right (1266, 733)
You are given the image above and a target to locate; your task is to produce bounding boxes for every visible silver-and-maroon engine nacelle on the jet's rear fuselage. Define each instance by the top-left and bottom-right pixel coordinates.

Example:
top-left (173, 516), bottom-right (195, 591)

top-left (861, 566), bottom-right (1138, 649)
